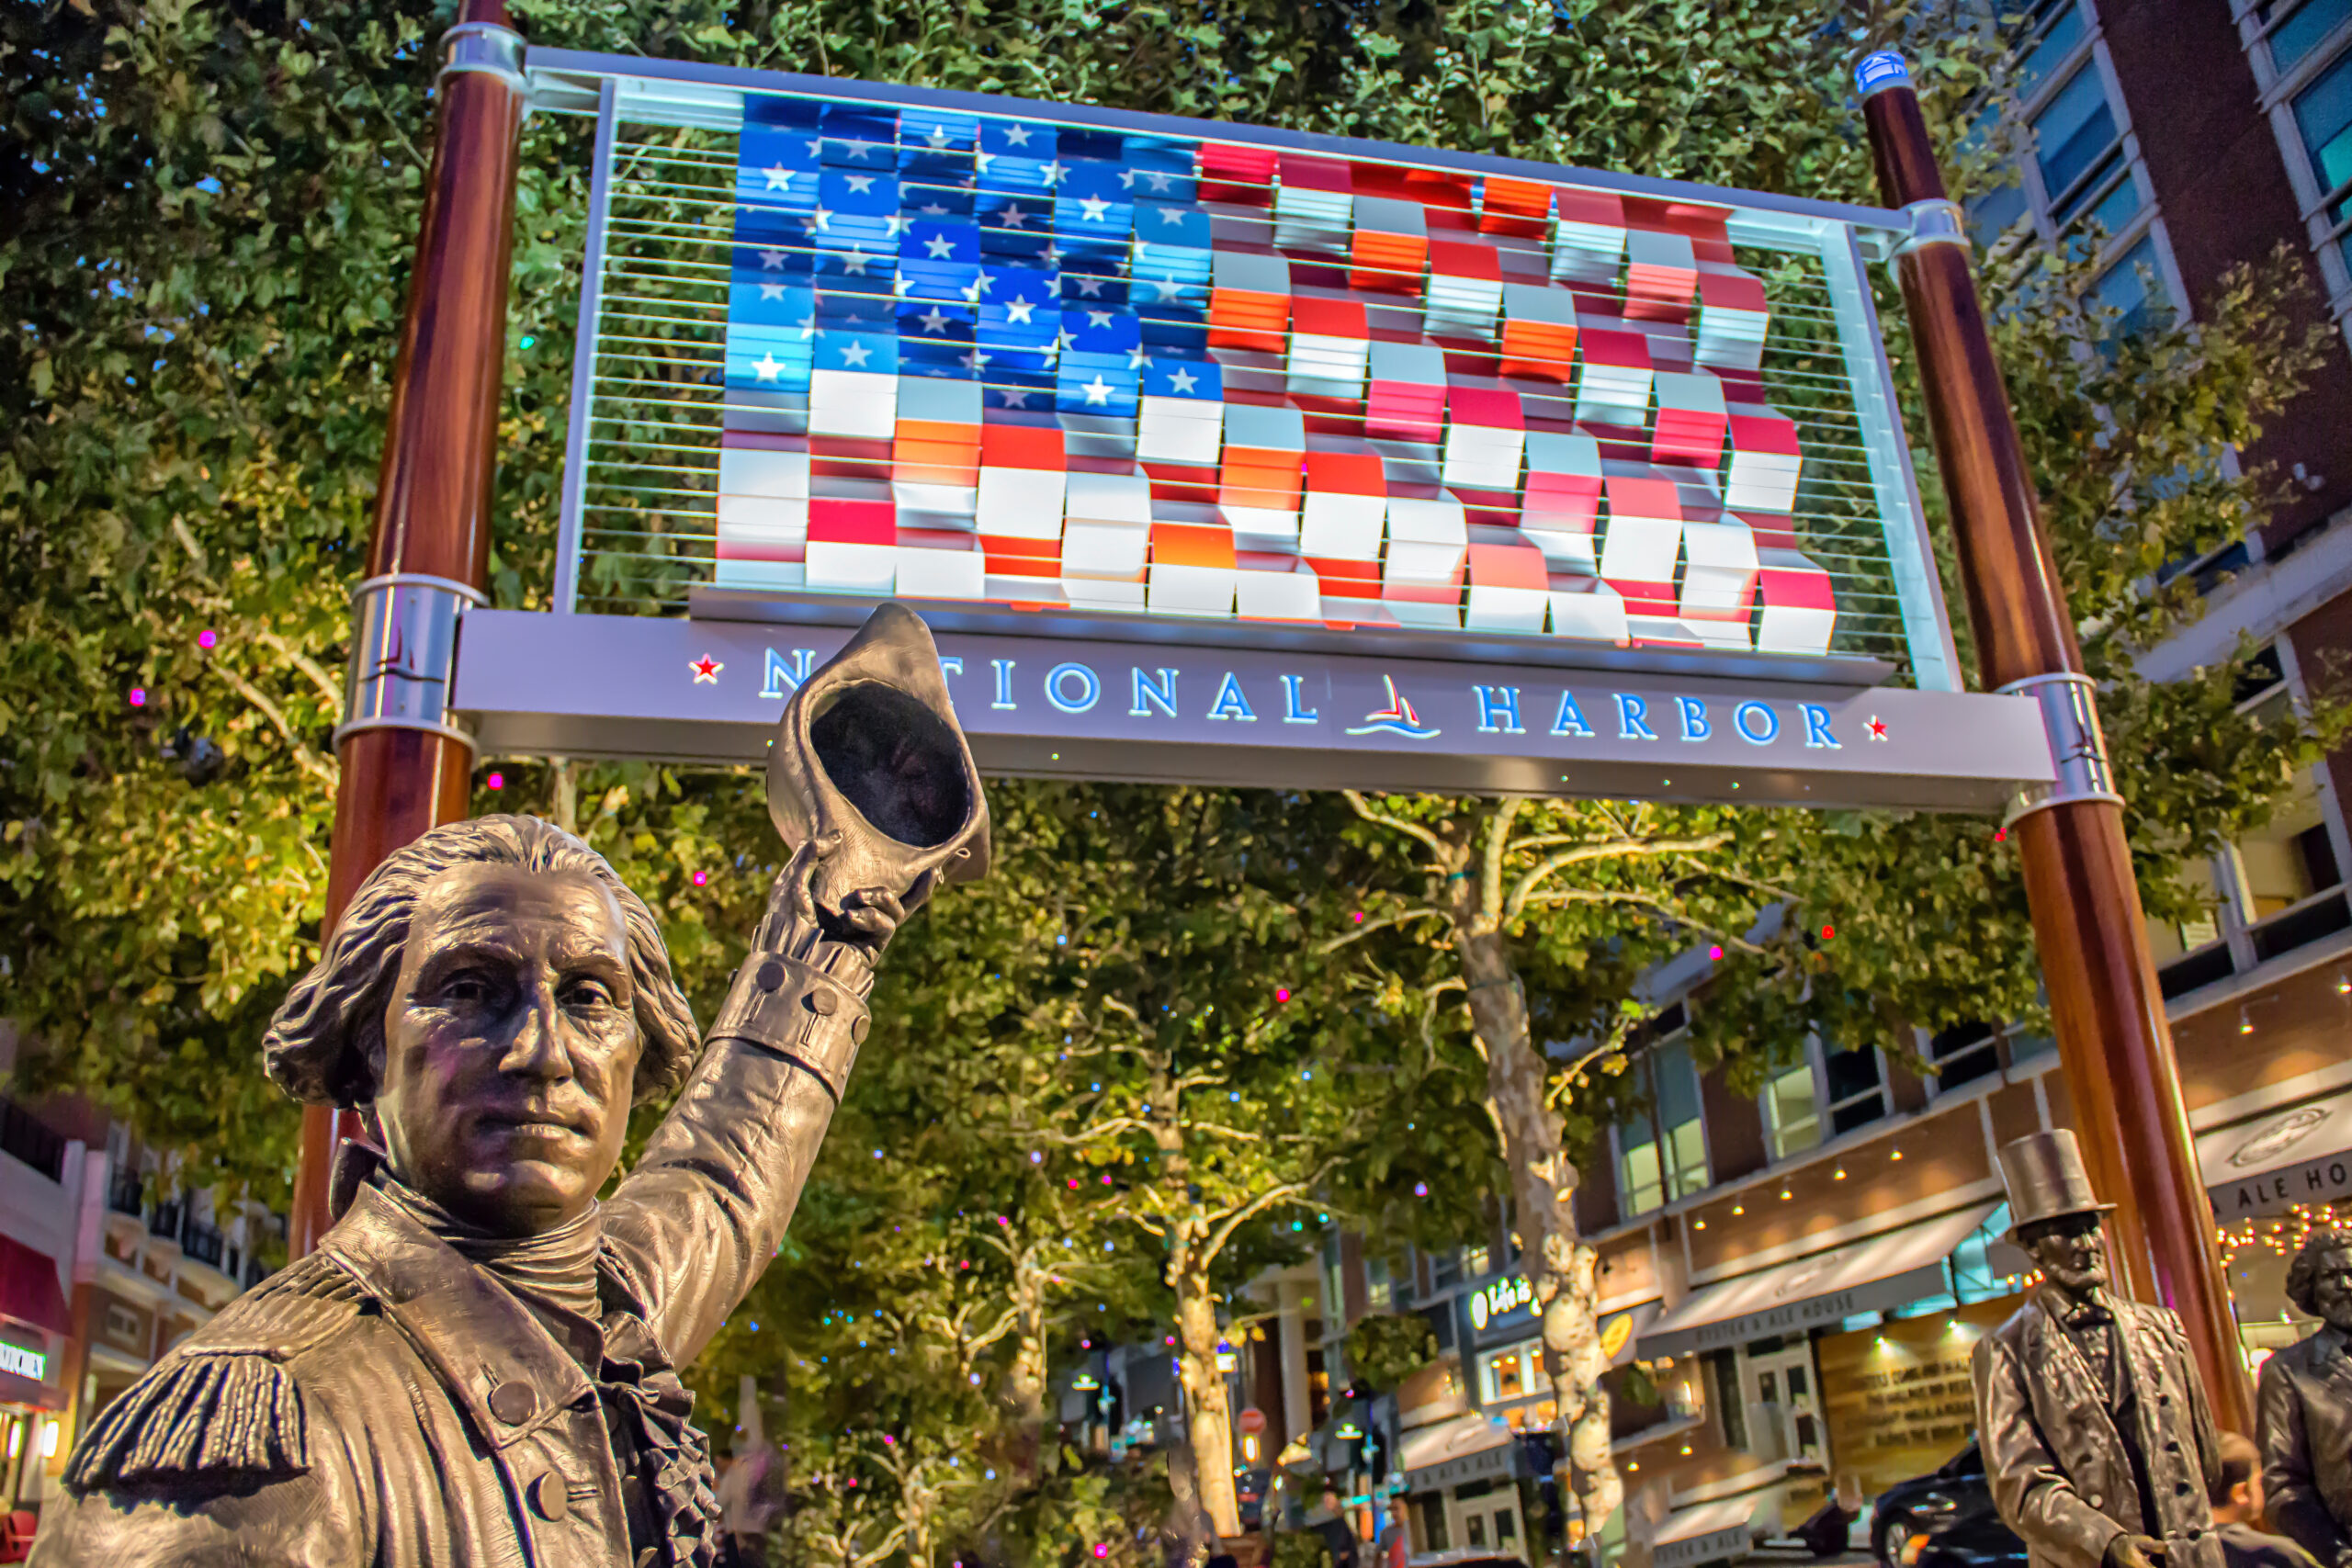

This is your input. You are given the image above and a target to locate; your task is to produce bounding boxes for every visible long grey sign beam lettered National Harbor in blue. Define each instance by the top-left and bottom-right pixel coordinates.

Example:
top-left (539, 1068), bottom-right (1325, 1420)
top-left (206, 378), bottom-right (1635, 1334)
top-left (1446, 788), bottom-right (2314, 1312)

top-left (454, 611), bottom-right (2051, 808)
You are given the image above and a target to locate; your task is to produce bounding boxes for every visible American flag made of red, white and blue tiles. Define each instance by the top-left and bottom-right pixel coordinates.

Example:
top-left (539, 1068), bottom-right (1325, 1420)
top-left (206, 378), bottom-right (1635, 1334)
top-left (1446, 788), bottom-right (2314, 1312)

top-left (715, 96), bottom-right (1839, 656)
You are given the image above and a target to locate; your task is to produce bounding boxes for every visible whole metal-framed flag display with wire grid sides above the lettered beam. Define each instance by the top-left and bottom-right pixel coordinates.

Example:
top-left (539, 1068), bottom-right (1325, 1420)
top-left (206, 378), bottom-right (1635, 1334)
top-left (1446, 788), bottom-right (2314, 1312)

top-left (526, 50), bottom-right (1959, 691)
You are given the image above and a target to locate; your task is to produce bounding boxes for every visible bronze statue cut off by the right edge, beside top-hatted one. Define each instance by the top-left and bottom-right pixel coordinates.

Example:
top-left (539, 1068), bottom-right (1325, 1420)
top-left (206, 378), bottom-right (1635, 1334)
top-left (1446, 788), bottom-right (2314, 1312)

top-left (2256, 1229), bottom-right (2352, 1568)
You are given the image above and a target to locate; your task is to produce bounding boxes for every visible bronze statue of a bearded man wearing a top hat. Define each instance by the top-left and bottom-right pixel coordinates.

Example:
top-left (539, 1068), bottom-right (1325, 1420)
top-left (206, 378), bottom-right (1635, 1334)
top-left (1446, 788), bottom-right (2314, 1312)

top-left (1973, 1131), bottom-right (2222, 1568)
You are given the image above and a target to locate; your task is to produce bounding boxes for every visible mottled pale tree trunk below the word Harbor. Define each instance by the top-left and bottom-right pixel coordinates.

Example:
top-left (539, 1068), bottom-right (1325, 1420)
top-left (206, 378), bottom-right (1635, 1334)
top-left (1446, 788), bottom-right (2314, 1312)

top-left (1453, 921), bottom-right (1625, 1540)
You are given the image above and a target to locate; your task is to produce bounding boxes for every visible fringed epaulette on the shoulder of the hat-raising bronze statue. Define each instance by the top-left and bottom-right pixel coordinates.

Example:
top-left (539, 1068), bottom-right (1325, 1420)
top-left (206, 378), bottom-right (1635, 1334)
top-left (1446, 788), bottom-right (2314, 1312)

top-left (66, 1253), bottom-right (362, 1493)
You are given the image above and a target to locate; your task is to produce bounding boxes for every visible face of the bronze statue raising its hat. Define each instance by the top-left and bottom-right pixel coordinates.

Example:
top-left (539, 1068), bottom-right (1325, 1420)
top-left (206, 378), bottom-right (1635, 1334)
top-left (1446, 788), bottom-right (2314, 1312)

top-left (377, 865), bottom-right (642, 1236)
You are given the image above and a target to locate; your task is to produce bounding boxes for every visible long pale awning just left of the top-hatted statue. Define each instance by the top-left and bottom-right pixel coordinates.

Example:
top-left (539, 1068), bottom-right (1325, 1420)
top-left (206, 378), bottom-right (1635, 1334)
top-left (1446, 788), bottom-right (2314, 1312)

top-left (1642, 1203), bottom-right (1996, 1359)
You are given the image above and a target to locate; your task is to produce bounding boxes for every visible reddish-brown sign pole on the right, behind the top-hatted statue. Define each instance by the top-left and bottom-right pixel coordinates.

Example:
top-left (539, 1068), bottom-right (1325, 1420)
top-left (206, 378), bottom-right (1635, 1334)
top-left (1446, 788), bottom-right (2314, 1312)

top-left (1856, 54), bottom-right (2253, 1434)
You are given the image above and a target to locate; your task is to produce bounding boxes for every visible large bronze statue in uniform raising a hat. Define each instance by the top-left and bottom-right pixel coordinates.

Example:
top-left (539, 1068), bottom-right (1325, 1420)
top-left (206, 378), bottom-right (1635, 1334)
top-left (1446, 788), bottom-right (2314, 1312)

top-left (33, 604), bottom-right (988, 1568)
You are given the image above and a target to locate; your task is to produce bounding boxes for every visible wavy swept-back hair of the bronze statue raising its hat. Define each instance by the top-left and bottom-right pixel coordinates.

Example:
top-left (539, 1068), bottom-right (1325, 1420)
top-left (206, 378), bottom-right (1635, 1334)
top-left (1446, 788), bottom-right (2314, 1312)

top-left (261, 816), bottom-right (701, 1107)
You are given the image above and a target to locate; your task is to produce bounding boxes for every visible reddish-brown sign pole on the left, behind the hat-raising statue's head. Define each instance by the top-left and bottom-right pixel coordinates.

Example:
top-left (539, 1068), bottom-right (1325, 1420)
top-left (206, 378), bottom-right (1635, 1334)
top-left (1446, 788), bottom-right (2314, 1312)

top-left (289, 0), bottom-right (525, 1258)
